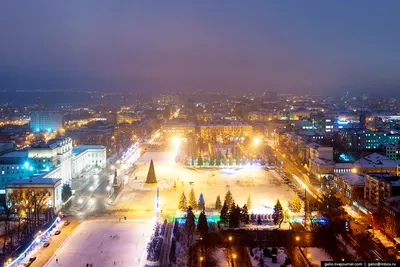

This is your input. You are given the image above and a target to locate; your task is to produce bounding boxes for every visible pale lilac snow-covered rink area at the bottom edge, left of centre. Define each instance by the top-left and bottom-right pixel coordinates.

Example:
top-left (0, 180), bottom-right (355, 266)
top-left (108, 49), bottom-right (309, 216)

top-left (46, 220), bottom-right (153, 267)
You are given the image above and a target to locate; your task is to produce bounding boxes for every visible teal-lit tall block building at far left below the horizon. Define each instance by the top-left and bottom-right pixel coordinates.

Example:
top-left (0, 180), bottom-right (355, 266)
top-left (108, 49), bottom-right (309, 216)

top-left (30, 111), bottom-right (62, 132)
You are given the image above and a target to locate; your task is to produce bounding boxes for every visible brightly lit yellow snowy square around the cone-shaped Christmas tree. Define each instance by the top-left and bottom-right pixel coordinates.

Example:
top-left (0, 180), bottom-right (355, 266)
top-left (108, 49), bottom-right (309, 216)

top-left (114, 152), bottom-right (294, 216)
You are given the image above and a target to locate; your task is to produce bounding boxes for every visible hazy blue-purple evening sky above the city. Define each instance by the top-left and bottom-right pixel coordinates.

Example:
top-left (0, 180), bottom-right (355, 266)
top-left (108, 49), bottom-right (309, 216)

top-left (0, 0), bottom-right (400, 95)
